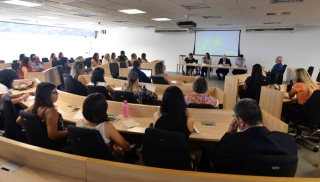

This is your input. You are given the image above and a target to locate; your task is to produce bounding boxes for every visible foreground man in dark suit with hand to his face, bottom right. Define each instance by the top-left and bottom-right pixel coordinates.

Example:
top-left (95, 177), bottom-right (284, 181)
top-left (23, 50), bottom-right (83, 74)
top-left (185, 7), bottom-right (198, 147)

top-left (200, 99), bottom-right (297, 174)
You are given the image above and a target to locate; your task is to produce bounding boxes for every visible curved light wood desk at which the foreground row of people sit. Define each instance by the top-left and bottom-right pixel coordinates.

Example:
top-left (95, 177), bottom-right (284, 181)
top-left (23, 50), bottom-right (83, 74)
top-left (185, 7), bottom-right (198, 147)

top-left (14, 83), bottom-right (288, 142)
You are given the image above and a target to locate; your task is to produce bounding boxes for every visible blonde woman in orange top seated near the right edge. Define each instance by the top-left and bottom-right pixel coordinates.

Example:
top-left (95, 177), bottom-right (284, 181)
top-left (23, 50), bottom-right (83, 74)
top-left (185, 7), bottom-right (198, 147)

top-left (285, 68), bottom-right (319, 125)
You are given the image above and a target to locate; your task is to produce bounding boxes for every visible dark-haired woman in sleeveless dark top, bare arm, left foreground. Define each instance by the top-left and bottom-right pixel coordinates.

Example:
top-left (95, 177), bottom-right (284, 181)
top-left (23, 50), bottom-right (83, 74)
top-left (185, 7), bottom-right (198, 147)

top-left (17, 82), bottom-right (68, 149)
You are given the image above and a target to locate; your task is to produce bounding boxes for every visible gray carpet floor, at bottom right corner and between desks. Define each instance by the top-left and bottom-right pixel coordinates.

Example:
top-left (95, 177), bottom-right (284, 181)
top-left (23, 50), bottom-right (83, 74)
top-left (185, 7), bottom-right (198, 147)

top-left (169, 72), bottom-right (320, 178)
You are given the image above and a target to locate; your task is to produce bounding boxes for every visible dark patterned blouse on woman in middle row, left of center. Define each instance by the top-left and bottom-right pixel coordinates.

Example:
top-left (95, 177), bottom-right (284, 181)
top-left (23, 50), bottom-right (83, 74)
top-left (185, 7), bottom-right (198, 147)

top-left (122, 83), bottom-right (158, 104)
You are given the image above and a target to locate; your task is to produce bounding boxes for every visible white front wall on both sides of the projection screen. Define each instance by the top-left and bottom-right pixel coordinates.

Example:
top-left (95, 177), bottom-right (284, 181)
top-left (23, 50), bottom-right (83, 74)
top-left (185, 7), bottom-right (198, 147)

top-left (92, 27), bottom-right (320, 78)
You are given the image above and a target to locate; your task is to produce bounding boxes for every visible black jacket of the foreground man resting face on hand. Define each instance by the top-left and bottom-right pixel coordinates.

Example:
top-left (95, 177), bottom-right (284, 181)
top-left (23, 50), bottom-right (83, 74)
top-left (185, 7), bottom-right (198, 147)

top-left (211, 126), bottom-right (297, 174)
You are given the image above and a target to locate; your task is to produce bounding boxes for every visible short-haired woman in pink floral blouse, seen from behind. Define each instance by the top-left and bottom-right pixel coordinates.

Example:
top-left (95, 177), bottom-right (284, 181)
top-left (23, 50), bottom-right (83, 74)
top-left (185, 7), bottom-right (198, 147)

top-left (185, 77), bottom-right (219, 108)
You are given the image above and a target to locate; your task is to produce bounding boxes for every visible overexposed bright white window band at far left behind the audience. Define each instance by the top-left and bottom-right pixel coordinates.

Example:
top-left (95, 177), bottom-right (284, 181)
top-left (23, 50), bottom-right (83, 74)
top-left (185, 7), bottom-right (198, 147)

top-left (0, 32), bottom-right (94, 62)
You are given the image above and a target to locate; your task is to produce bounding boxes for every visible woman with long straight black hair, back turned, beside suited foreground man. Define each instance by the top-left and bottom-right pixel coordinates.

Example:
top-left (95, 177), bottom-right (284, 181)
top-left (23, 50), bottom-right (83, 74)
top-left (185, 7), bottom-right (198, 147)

top-left (153, 86), bottom-right (194, 139)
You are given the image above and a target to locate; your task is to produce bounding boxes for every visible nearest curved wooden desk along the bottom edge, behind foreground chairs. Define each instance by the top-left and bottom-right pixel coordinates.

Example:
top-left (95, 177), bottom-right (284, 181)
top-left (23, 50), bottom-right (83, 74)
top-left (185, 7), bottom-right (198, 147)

top-left (0, 137), bottom-right (316, 182)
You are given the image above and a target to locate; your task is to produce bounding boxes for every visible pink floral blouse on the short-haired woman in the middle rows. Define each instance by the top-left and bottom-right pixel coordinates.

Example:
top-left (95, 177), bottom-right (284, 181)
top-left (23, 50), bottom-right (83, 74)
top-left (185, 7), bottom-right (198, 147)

top-left (185, 93), bottom-right (219, 108)
